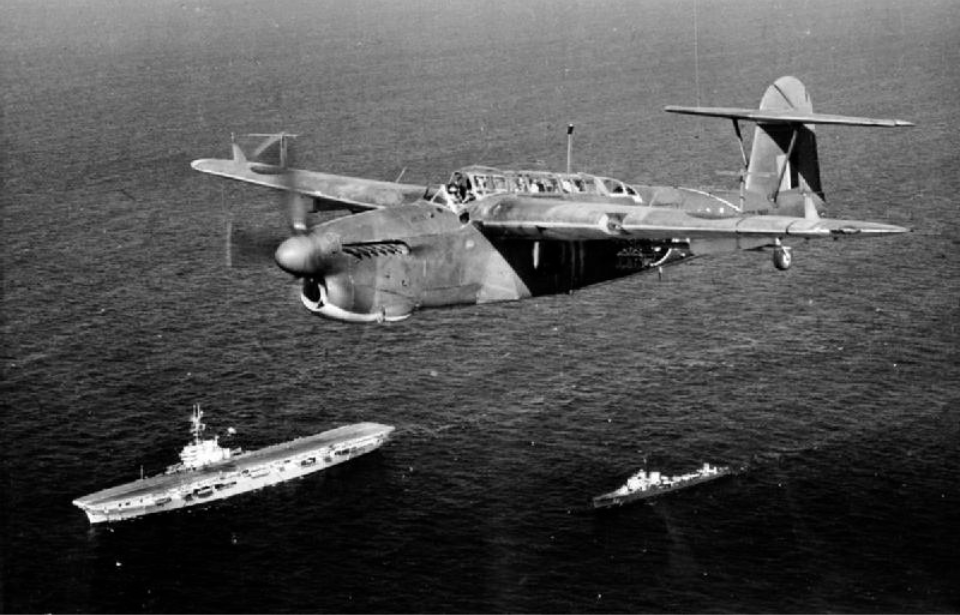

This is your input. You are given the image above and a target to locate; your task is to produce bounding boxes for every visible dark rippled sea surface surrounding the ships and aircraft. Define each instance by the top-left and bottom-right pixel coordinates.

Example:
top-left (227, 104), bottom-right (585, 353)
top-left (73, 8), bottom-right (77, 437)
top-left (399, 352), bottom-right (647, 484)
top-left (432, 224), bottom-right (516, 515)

top-left (0, 0), bottom-right (960, 612)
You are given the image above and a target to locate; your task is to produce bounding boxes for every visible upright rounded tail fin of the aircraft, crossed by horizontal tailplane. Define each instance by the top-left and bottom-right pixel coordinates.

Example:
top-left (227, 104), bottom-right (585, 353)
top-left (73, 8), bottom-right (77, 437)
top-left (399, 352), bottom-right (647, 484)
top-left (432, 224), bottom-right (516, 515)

top-left (746, 77), bottom-right (824, 199)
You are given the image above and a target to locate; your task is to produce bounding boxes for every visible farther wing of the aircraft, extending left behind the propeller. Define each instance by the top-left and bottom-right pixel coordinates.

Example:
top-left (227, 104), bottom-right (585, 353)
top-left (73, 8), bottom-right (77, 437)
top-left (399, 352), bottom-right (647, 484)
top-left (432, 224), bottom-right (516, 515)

top-left (190, 153), bottom-right (426, 212)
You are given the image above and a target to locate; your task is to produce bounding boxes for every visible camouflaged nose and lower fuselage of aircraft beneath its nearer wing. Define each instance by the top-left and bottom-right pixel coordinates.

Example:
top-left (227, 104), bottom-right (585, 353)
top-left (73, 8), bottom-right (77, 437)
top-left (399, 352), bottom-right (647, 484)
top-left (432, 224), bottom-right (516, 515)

top-left (294, 202), bottom-right (691, 322)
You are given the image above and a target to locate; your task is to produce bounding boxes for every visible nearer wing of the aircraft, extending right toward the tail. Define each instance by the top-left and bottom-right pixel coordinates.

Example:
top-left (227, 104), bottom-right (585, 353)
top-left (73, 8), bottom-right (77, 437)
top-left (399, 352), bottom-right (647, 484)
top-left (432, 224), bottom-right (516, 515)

top-left (471, 196), bottom-right (908, 254)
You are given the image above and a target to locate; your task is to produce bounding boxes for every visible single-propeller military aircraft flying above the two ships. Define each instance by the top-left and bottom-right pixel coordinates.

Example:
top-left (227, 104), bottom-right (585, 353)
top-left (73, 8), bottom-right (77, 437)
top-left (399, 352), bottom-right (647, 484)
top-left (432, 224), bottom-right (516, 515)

top-left (192, 77), bottom-right (912, 322)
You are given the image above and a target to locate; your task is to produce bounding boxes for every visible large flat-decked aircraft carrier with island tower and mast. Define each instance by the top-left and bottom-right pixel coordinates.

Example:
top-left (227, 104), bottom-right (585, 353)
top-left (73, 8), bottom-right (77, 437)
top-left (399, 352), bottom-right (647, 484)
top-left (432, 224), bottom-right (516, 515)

top-left (73, 404), bottom-right (394, 523)
